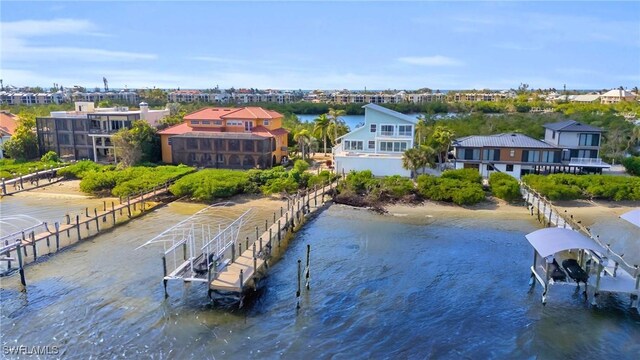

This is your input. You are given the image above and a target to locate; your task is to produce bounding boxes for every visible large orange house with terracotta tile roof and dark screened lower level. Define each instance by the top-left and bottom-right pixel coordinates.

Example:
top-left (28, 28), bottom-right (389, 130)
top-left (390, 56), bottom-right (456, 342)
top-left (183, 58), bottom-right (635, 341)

top-left (158, 107), bottom-right (289, 169)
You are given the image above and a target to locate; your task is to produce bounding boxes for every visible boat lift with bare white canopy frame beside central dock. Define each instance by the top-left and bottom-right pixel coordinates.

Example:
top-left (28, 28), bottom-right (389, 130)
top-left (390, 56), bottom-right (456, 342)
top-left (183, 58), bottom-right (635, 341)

top-left (136, 202), bottom-right (253, 295)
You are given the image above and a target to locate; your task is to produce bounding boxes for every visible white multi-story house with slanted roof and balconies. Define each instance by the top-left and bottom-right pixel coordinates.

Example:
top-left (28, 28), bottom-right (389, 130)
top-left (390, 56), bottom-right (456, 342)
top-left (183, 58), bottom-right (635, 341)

top-left (333, 104), bottom-right (418, 176)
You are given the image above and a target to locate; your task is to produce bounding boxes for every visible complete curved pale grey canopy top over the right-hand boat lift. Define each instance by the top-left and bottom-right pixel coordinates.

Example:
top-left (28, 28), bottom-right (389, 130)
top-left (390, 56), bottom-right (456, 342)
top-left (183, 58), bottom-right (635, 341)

top-left (525, 228), bottom-right (606, 257)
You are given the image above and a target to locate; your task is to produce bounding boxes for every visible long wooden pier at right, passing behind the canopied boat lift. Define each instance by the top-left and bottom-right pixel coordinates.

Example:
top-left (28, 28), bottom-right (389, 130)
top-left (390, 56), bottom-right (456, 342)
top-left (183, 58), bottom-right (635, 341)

top-left (520, 183), bottom-right (640, 307)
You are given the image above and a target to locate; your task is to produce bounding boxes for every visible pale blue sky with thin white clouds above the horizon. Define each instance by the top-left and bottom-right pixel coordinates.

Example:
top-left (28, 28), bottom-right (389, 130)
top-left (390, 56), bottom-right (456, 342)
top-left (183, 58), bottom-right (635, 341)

top-left (0, 0), bottom-right (640, 89)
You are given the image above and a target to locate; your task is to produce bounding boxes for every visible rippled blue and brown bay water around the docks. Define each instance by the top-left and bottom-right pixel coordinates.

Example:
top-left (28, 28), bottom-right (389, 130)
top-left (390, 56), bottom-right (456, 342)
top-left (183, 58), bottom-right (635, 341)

top-left (0, 199), bottom-right (640, 359)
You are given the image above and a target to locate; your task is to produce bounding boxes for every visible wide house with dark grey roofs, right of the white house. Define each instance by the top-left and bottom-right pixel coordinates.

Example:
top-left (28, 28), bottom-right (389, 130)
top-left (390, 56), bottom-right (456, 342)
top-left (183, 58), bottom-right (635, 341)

top-left (453, 120), bottom-right (611, 179)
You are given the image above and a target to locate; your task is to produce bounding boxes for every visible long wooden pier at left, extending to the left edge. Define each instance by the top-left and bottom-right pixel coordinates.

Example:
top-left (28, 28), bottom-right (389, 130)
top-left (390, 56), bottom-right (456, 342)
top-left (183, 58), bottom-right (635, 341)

top-left (0, 182), bottom-right (170, 290)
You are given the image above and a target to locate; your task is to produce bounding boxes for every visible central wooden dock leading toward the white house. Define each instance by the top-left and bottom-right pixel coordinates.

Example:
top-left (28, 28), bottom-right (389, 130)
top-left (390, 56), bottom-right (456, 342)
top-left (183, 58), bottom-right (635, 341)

top-left (208, 182), bottom-right (337, 300)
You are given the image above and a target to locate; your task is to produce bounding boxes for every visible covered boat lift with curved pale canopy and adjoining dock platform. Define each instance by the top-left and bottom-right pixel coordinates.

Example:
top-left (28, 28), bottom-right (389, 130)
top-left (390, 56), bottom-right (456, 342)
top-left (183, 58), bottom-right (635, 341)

top-left (525, 227), bottom-right (640, 309)
